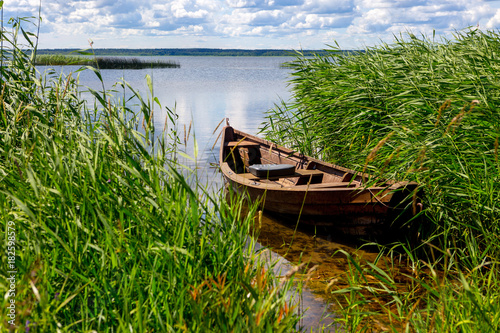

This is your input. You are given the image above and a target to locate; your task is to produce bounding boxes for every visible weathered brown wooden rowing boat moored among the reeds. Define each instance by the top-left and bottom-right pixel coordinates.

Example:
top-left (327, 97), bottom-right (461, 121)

top-left (219, 126), bottom-right (417, 235)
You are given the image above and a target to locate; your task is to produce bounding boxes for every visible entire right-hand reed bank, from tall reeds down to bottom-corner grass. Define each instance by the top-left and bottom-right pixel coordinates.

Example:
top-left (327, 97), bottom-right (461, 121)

top-left (263, 29), bottom-right (500, 332)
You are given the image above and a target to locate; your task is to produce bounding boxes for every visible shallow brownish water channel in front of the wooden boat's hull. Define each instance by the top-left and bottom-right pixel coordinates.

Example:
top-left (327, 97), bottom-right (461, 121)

top-left (246, 206), bottom-right (377, 332)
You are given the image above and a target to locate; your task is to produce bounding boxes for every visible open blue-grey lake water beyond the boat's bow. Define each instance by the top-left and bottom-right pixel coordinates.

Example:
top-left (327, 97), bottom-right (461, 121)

top-left (60, 56), bottom-right (293, 186)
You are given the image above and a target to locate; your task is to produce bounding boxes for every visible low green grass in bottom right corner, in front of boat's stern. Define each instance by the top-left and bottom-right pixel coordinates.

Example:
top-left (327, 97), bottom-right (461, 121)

top-left (332, 245), bottom-right (500, 332)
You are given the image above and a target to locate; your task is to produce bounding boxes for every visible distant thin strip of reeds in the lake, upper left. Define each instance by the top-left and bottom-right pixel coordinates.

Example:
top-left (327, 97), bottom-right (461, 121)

top-left (35, 54), bottom-right (180, 69)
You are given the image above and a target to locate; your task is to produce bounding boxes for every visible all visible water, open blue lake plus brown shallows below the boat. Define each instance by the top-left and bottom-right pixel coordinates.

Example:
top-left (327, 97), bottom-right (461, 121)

top-left (40, 57), bottom-right (344, 330)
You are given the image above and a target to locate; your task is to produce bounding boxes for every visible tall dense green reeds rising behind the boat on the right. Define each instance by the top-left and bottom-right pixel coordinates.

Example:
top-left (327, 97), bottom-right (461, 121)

top-left (263, 29), bottom-right (500, 255)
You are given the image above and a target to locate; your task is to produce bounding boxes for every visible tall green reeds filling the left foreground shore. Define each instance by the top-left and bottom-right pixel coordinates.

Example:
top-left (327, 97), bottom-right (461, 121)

top-left (0, 11), bottom-right (299, 332)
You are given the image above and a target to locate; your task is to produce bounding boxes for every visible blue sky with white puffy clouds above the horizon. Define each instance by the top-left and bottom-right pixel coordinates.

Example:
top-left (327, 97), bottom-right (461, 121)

top-left (3, 0), bottom-right (500, 50)
